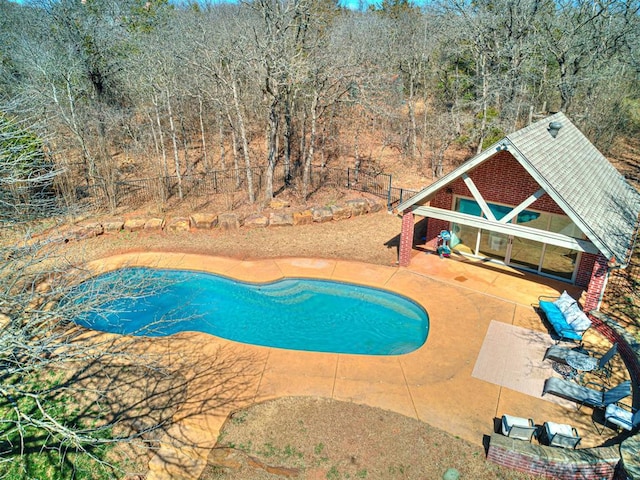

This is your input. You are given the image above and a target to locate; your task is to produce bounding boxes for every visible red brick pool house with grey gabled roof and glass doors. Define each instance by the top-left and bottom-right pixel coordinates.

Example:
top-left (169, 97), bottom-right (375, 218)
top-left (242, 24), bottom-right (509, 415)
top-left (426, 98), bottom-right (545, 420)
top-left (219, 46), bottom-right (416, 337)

top-left (398, 113), bottom-right (640, 311)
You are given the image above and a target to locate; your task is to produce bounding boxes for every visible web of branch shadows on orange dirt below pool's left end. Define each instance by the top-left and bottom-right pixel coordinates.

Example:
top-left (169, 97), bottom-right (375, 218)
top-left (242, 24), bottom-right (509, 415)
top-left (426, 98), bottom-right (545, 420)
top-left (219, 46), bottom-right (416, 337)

top-left (0, 331), bottom-right (264, 478)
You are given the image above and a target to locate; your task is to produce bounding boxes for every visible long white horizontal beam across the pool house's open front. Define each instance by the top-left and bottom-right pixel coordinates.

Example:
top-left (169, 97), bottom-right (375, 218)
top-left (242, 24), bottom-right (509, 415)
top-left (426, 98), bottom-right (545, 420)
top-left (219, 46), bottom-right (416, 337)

top-left (413, 207), bottom-right (599, 254)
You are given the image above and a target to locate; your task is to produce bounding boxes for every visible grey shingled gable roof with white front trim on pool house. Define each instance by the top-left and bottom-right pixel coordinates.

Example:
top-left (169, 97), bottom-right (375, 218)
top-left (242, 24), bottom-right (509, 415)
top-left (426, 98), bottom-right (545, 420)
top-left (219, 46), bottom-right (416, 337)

top-left (398, 113), bottom-right (640, 265)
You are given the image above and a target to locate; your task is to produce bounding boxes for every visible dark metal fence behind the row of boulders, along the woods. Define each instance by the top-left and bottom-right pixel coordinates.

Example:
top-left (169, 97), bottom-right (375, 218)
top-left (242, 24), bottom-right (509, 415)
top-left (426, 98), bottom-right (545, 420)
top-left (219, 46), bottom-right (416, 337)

top-left (76, 165), bottom-right (416, 209)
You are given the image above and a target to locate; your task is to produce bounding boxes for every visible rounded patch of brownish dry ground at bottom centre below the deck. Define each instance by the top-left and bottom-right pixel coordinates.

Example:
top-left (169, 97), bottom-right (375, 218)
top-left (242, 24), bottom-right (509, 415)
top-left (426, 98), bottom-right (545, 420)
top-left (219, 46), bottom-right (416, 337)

top-left (200, 397), bottom-right (538, 480)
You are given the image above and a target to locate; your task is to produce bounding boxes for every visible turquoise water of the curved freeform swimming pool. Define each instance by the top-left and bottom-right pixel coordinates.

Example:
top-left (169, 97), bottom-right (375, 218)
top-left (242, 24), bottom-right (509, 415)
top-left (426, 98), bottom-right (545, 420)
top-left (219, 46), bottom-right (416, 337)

top-left (74, 268), bottom-right (429, 355)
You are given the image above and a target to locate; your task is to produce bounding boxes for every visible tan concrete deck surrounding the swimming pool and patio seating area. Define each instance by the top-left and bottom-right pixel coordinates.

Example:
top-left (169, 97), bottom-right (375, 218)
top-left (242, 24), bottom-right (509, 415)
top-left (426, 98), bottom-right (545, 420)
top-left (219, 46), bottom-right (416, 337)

top-left (84, 252), bottom-right (620, 480)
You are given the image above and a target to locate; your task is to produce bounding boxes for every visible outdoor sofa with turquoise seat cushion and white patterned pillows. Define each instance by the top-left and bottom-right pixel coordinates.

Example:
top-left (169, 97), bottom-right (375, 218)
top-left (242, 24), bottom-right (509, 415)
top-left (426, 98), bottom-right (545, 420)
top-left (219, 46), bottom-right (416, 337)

top-left (538, 291), bottom-right (591, 342)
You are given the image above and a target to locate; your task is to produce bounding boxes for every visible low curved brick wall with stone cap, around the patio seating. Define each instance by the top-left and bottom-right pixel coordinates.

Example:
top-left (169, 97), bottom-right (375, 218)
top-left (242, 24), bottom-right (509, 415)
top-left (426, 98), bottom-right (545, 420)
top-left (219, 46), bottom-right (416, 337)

top-left (487, 311), bottom-right (640, 480)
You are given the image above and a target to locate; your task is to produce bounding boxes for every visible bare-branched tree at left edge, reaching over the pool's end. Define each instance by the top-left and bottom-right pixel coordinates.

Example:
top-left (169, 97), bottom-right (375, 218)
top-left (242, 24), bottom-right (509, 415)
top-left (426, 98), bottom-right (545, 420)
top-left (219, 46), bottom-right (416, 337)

top-left (0, 109), bottom-right (260, 478)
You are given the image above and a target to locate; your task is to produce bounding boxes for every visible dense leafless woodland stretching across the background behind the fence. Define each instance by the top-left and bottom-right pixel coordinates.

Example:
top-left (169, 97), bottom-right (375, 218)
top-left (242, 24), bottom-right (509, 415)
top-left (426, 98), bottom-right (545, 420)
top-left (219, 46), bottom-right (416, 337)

top-left (0, 0), bottom-right (640, 217)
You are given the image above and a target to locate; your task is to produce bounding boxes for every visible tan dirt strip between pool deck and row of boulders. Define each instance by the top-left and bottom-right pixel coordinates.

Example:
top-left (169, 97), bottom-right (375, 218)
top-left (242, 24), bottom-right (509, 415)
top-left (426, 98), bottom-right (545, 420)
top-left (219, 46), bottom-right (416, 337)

top-left (68, 205), bottom-right (401, 265)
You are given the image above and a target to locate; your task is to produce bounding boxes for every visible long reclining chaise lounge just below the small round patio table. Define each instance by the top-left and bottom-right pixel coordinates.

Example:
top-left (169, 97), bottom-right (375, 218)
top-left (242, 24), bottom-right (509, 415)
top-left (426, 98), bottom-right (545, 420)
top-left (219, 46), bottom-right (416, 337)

top-left (542, 377), bottom-right (631, 408)
